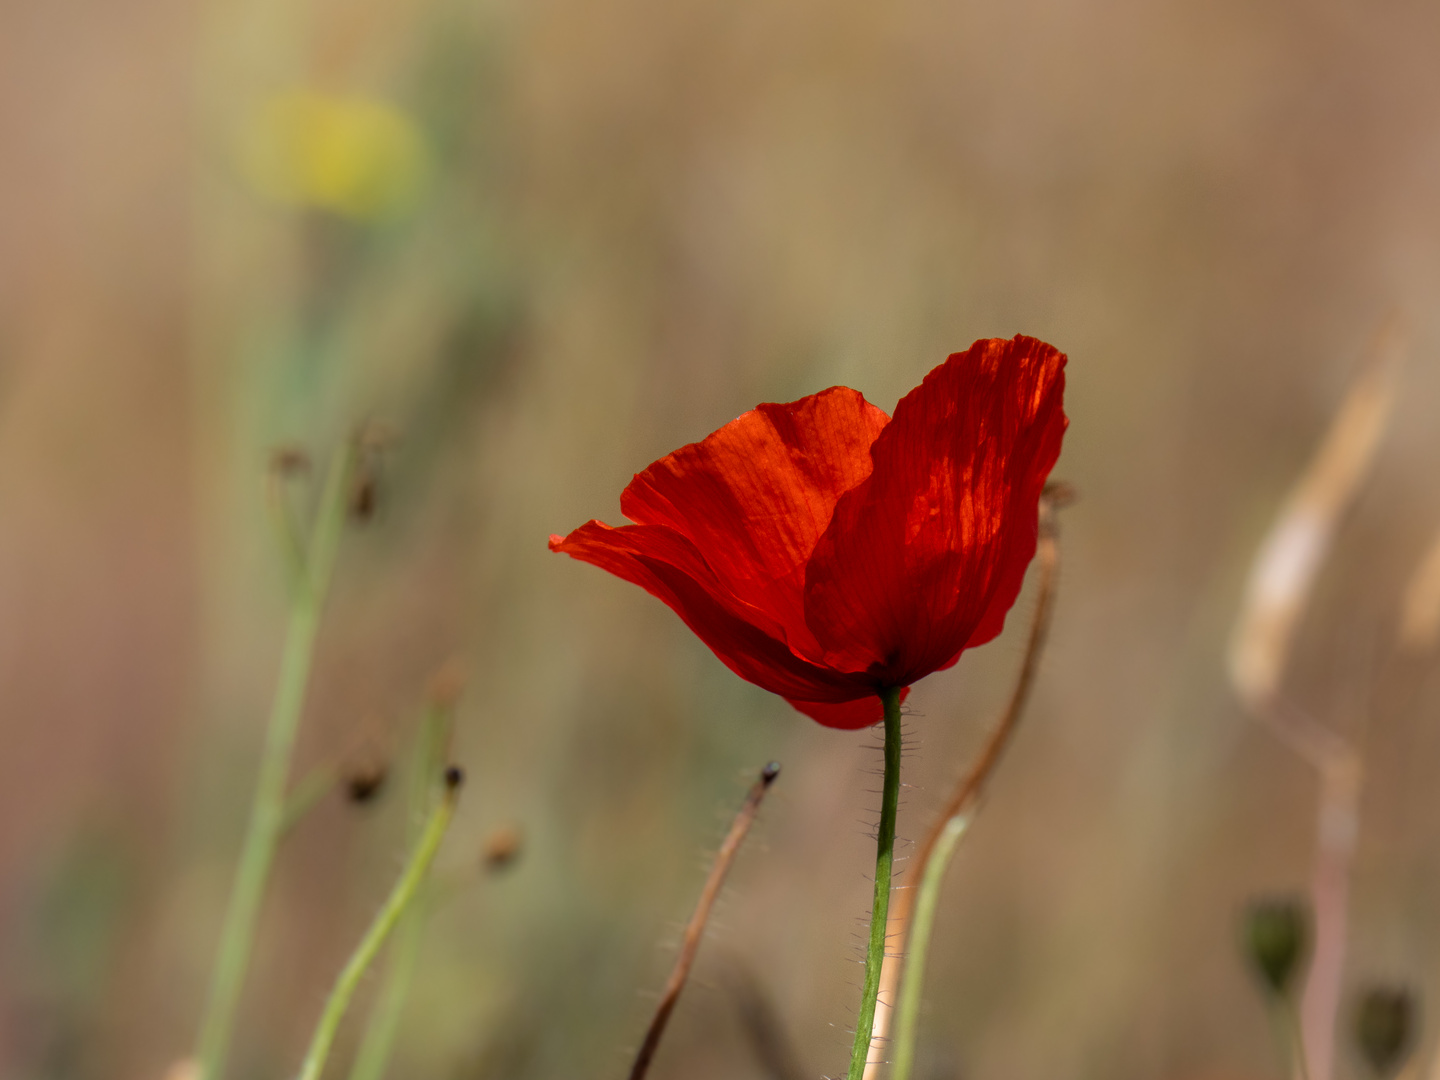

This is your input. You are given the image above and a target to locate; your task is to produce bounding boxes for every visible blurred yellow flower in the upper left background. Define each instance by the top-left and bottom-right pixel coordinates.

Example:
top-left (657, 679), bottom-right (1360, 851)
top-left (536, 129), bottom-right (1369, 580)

top-left (240, 91), bottom-right (431, 220)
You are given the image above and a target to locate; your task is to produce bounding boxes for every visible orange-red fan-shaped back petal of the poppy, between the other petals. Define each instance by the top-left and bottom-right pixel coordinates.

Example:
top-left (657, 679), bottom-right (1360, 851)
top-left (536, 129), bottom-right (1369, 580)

top-left (621, 386), bottom-right (890, 660)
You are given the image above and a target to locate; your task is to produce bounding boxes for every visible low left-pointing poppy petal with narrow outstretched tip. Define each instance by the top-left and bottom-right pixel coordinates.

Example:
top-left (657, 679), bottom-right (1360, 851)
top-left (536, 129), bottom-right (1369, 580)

top-left (550, 521), bottom-right (878, 701)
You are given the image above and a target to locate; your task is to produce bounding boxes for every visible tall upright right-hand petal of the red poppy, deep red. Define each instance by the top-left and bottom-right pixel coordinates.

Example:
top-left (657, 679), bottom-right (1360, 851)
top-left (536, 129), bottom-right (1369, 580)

top-left (805, 337), bottom-right (1067, 685)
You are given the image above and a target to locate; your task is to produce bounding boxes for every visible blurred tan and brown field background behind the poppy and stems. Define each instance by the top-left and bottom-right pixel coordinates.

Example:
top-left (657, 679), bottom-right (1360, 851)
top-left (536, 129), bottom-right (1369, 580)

top-left (0, 0), bottom-right (1440, 1080)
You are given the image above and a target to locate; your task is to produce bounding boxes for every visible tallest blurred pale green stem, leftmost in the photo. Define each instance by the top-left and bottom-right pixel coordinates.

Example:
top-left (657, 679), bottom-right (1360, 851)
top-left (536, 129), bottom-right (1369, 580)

top-left (196, 444), bottom-right (353, 1080)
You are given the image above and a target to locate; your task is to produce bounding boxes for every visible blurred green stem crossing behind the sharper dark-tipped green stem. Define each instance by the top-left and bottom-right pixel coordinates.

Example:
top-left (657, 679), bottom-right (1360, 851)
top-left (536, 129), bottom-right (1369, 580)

top-left (342, 703), bottom-right (454, 1080)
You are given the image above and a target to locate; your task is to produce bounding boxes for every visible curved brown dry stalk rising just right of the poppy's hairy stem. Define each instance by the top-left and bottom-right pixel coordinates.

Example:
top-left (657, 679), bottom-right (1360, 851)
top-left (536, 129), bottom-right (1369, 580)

top-left (864, 485), bottom-right (1071, 1080)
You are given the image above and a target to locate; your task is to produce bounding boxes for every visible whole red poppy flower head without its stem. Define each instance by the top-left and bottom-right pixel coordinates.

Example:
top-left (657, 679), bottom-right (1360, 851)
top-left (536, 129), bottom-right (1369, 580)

top-left (550, 337), bottom-right (1067, 727)
